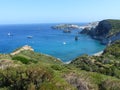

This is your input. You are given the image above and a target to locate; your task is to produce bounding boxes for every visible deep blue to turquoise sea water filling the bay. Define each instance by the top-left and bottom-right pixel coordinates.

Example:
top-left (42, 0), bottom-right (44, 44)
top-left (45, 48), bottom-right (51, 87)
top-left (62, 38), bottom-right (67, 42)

top-left (0, 24), bottom-right (105, 62)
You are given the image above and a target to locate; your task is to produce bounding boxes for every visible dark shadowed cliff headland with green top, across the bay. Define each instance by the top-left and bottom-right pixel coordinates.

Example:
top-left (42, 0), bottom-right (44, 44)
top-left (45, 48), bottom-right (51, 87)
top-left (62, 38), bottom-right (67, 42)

top-left (81, 20), bottom-right (120, 44)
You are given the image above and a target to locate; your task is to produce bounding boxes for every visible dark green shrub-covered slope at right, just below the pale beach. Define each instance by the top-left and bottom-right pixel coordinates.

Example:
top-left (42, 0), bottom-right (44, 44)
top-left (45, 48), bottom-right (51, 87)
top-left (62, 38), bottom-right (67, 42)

top-left (71, 41), bottom-right (120, 78)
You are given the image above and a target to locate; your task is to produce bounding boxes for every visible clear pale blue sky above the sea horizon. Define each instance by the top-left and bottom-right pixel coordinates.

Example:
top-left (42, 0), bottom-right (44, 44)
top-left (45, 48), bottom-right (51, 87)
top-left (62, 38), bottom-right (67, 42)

top-left (0, 0), bottom-right (120, 24)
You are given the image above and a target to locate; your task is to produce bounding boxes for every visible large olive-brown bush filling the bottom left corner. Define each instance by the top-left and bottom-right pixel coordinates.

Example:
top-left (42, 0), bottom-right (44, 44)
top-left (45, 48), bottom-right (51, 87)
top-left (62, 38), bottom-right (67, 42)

top-left (0, 65), bottom-right (52, 90)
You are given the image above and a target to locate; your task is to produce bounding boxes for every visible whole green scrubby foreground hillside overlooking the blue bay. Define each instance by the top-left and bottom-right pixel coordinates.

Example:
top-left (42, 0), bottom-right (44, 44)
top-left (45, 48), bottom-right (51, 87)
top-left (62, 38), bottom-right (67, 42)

top-left (0, 42), bottom-right (120, 90)
